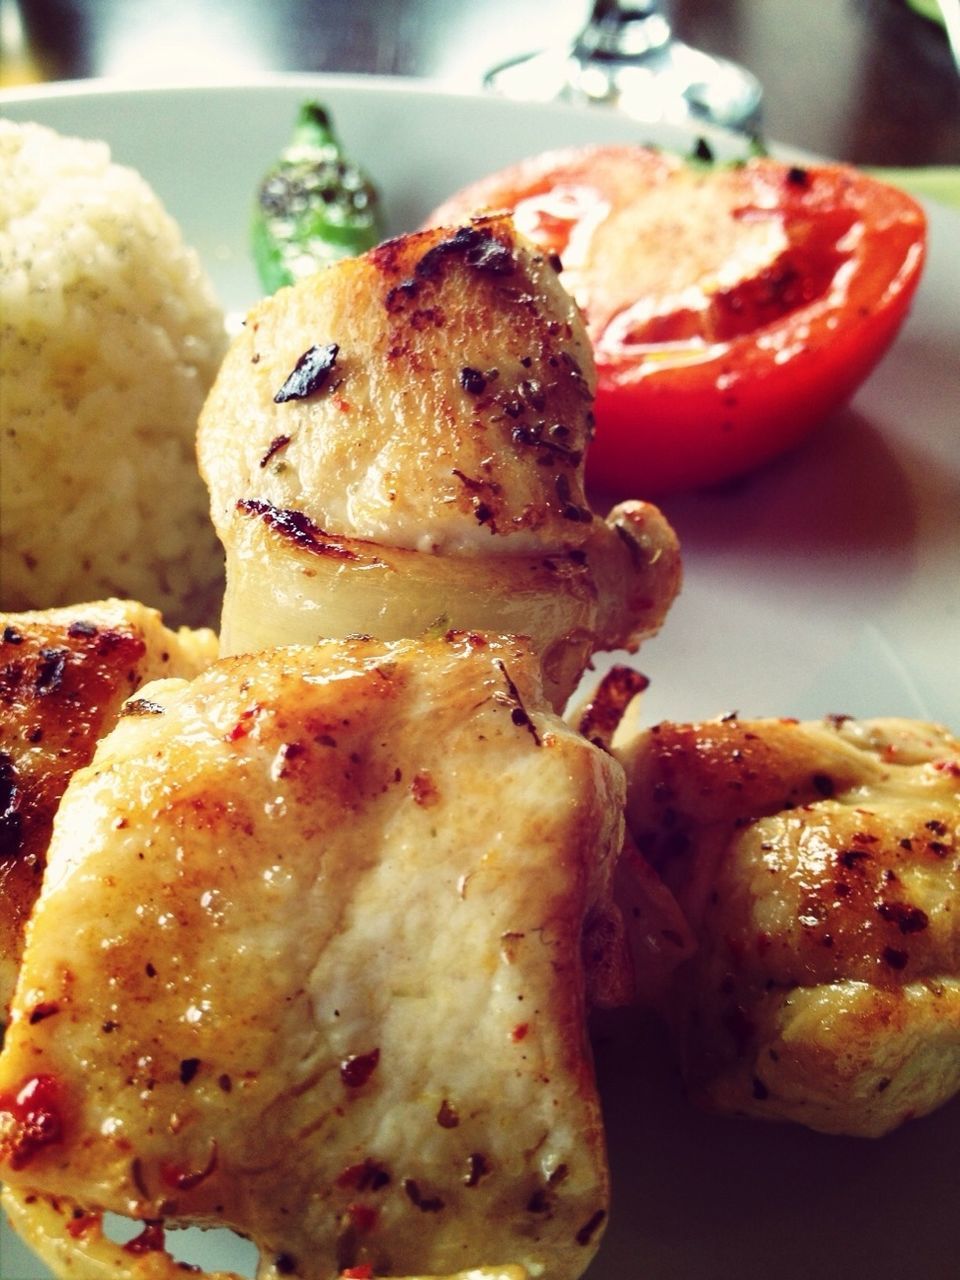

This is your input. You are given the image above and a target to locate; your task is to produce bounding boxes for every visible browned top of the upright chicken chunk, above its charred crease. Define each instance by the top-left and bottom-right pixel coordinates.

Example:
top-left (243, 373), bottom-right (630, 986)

top-left (200, 219), bottom-right (594, 554)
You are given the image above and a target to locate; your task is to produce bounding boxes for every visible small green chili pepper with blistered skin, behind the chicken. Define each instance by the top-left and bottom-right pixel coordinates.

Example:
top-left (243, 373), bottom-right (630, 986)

top-left (252, 102), bottom-right (383, 293)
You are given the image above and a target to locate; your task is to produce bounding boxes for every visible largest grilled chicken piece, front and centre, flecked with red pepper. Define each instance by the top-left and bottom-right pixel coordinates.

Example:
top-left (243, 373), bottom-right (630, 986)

top-left (0, 634), bottom-right (623, 1280)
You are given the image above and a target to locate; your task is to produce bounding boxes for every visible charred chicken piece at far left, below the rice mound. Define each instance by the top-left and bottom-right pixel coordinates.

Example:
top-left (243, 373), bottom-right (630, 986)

top-left (0, 600), bottom-right (216, 1021)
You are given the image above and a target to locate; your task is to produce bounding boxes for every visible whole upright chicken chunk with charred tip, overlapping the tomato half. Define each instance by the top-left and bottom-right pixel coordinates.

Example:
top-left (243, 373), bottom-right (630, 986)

top-left (198, 218), bottom-right (680, 709)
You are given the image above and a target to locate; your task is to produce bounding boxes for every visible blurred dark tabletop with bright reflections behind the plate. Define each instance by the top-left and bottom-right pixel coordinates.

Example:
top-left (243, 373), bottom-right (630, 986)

top-left (0, 0), bottom-right (960, 166)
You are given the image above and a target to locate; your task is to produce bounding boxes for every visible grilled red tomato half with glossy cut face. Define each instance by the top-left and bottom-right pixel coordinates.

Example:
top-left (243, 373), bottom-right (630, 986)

top-left (433, 147), bottom-right (925, 497)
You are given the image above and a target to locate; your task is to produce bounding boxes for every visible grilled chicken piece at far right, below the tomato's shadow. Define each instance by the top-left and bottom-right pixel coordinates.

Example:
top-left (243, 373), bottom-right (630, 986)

top-left (614, 717), bottom-right (960, 1137)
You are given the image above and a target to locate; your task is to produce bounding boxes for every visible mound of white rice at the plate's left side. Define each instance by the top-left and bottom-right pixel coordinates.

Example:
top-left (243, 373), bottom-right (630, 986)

top-left (0, 120), bottom-right (227, 626)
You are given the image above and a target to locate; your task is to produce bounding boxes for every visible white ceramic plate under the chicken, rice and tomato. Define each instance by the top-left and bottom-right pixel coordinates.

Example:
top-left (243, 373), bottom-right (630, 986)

top-left (0, 76), bottom-right (960, 1280)
